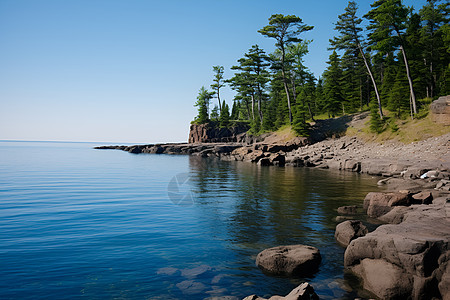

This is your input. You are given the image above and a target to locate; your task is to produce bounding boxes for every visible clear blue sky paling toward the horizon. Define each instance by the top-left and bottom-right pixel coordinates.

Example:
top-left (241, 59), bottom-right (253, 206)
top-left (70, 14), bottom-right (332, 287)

top-left (0, 0), bottom-right (425, 143)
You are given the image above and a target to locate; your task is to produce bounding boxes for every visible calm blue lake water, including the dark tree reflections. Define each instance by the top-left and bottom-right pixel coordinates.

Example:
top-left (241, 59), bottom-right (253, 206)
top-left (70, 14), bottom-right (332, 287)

top-left (0, 142), bottom-right (377, 299)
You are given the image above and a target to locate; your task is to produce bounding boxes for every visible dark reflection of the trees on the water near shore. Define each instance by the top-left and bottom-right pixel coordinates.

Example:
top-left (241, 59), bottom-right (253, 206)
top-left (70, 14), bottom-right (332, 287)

top-left (185, 157), bottom-right (377, 299)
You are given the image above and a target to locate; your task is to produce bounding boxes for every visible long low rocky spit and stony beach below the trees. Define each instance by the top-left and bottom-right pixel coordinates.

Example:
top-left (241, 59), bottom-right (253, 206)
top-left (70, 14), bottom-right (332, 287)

top-left (96, 134), bottom-right (450, 183)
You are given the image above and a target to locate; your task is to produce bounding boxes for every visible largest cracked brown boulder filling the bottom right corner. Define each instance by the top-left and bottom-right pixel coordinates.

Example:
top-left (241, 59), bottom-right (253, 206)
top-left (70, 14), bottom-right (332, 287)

top-left (344, 198), bottom-right (450, 299)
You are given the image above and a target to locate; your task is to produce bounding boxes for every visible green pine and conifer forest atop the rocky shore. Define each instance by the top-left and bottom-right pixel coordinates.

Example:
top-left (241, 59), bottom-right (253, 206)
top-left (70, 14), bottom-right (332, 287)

top-left (194, 0), bottom-right (450, 136)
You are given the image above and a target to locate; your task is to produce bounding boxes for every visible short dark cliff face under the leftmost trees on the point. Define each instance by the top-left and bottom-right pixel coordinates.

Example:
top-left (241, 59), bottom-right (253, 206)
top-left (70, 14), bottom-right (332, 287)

top-left (189, 122), bottom-right (250, 143)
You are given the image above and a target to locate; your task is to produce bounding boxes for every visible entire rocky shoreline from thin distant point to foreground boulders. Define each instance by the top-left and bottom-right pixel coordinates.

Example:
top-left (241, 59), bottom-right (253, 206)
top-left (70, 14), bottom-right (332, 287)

top-left (97, 134), bottom-right (450, 299)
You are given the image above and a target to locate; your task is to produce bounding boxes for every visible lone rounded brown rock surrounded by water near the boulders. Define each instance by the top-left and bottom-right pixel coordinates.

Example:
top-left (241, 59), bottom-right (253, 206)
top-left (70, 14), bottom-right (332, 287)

top-left (256, 245), bottom-right (322, 277)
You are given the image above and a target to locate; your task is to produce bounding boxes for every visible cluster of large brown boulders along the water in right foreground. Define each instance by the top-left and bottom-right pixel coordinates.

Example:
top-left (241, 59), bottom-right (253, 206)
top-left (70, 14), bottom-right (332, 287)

top-left (335, 190), bottom-right (450, 299)
